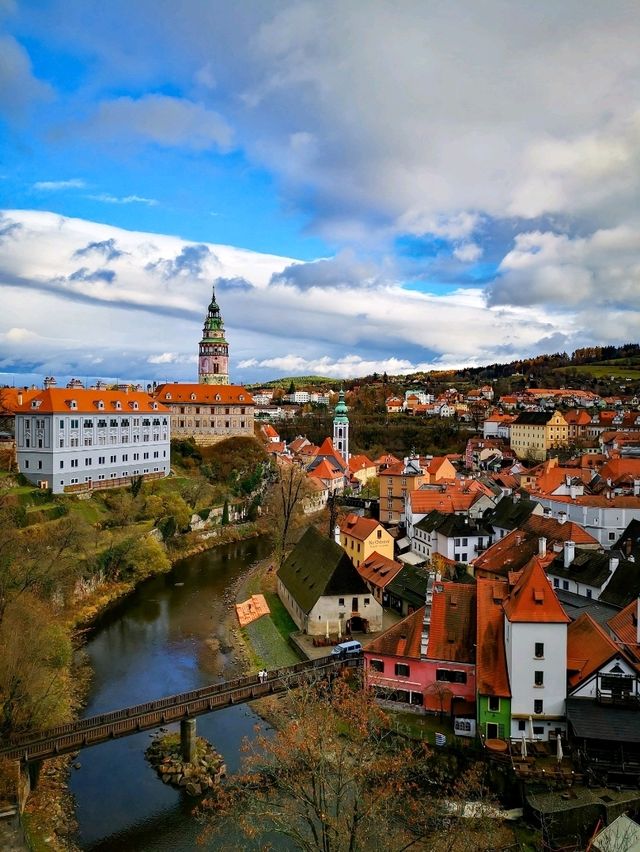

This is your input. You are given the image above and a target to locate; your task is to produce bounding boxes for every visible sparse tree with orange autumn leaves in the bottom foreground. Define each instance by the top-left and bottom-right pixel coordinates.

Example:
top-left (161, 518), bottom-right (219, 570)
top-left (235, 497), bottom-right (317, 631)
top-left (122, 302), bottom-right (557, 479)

top-left (204, 676), bottom-right (512, 852)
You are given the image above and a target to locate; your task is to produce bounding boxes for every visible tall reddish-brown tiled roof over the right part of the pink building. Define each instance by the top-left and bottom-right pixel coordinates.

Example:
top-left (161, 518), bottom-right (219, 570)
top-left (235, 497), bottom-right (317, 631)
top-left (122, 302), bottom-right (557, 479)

top-left (427, 583), bottom-right (476, 663)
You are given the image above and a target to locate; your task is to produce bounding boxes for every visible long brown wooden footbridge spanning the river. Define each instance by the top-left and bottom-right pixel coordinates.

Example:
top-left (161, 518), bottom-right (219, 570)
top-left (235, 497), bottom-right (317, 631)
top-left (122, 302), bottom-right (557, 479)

top-left (0, 657), bottom-right (362, 763)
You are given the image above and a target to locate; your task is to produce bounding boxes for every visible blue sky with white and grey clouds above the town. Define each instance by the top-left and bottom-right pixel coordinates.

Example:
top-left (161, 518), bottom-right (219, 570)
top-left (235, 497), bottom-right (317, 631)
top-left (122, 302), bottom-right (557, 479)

top-left (0, 0), bottom-right (640, 384)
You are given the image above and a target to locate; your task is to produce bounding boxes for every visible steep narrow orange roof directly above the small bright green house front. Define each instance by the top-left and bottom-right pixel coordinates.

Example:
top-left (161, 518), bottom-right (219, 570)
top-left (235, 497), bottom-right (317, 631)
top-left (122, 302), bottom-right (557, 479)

top-left (476, 579), bottom-right (511, 698)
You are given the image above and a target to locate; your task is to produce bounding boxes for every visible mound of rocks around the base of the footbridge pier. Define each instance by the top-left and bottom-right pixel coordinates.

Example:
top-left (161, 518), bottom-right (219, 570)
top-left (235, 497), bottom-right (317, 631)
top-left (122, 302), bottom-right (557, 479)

top-left (145, 734), bottom-right (227, 798)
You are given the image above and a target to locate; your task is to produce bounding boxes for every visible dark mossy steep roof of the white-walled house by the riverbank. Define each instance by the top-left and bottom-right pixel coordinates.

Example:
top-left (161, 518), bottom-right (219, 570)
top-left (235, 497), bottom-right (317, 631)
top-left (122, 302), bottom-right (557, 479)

top-left (278, 527), bottom-right (368, 613)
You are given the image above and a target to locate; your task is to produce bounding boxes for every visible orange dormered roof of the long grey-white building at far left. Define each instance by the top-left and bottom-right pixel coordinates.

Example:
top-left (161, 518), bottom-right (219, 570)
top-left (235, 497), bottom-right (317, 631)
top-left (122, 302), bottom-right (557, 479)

top-left (16, 388), bottom-right (170, 414)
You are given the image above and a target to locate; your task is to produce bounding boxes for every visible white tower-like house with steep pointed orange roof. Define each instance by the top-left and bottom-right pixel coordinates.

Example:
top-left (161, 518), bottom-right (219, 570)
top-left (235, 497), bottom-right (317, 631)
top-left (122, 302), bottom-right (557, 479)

top-left (504, 557), bottom-right (570, 740)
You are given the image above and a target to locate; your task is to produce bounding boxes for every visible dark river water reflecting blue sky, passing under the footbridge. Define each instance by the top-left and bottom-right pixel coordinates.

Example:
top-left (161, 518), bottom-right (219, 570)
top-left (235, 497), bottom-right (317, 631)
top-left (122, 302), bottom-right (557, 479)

top-left (70, 538), bottom-right (270, 852)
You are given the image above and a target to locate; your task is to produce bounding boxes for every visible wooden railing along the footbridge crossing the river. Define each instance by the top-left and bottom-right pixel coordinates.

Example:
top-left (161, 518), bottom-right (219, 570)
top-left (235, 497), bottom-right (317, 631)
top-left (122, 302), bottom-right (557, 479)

top-left (0, 656), bottom-right (361, 755)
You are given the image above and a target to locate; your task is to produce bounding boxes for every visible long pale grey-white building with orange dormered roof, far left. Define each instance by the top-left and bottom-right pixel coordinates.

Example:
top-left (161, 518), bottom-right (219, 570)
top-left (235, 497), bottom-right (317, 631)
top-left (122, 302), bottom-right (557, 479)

top-left (15, 387), bottom-right (170, 494)
